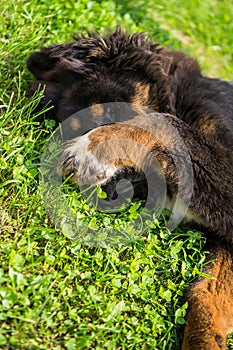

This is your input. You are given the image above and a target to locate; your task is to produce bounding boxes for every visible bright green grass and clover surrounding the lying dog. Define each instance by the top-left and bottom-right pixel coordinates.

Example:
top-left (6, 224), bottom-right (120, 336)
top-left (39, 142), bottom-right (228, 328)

top-left (0, 0), bottom-right (233, 350)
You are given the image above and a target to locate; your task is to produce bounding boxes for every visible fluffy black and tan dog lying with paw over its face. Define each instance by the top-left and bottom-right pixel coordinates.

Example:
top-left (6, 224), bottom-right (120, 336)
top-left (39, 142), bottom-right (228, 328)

top-left (27, 27), bottom-right (233, 350)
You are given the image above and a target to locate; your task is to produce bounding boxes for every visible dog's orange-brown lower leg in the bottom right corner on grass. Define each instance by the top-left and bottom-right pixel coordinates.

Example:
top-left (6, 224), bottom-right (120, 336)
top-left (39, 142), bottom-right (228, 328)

top-left (182, 243), bottom-right (233, 350)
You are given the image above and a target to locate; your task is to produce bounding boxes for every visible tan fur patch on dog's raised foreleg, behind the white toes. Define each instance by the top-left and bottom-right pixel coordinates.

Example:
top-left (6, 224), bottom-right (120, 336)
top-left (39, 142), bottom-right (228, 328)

top-left (88, 116), bottom-right (172, 173)
